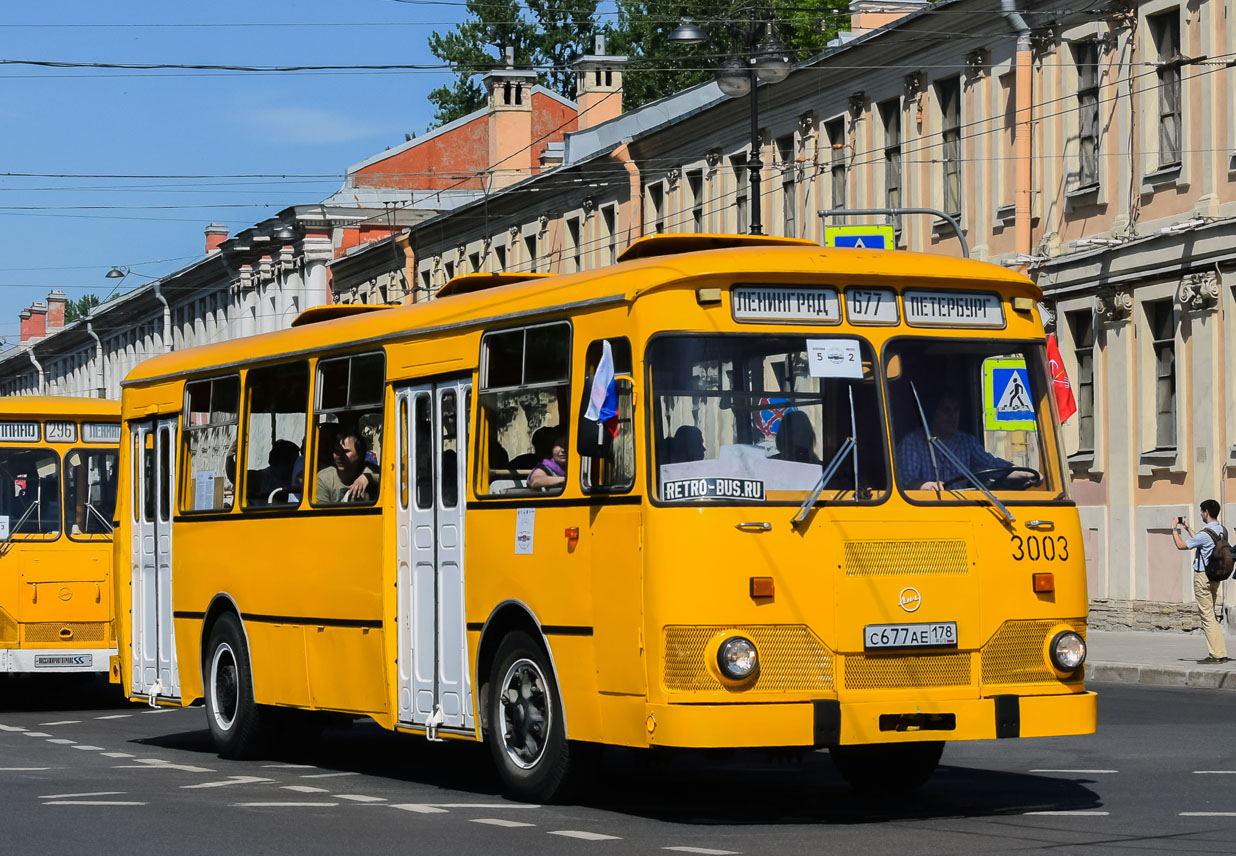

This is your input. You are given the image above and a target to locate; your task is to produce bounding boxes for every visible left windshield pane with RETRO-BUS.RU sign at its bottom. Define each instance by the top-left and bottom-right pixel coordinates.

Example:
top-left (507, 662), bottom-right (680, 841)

top-left (649, 335), bottom-right (889, 503)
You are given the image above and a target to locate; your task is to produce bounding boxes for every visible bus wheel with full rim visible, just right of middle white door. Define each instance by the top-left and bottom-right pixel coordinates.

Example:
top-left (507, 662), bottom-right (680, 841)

top-left (487, 631), bottom-right (578, 803)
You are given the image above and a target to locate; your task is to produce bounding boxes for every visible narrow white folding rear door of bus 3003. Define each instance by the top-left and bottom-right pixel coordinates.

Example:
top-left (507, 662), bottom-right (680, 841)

top-left (130, 419), bottom-right (180, 704)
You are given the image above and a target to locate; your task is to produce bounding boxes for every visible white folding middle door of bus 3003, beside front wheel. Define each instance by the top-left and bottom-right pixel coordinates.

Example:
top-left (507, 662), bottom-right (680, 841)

top-left (396, 380), bottom-right (473, 739)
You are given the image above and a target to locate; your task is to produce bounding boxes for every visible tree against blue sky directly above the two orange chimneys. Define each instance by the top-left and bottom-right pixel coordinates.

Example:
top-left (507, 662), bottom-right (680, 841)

top-left (429, 0), bottom-right (598, 127)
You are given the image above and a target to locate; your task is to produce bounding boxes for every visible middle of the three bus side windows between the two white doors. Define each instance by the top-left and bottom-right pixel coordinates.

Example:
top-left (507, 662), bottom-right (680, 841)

top-left (245, 362), bottom-right (309, 508)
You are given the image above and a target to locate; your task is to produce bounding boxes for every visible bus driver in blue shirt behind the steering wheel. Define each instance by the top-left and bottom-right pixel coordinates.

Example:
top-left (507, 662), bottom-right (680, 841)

top-left (897, 390), bottom-right (1039, 490)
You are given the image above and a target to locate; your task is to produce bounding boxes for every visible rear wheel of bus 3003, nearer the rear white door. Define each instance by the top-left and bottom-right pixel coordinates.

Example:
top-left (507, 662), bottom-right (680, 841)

top-left (201, 614), bottom-right (265, 758)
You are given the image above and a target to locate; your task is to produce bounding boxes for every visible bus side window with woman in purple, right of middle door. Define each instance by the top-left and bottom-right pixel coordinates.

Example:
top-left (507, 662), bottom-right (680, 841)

top-left (476, 321), bottom-right (571, 497)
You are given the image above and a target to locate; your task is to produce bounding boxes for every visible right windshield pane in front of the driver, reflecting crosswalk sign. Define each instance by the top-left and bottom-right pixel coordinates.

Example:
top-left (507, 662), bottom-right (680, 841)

top-left (885, 338), bottom-right (1063, 500)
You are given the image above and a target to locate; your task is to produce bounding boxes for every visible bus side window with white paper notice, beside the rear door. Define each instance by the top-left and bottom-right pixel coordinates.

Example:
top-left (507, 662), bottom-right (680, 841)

top-left (181, 374), bottom-right (240, 511)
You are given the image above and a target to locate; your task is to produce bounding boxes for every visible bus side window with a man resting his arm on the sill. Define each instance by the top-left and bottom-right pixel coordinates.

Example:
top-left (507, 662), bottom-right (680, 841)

top-left (313, 353), bottom-right (386, 505)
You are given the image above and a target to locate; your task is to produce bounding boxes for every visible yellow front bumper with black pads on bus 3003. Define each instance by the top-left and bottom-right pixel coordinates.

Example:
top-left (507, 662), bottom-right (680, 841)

top-left (645, 692), bottom-right (1098, 749)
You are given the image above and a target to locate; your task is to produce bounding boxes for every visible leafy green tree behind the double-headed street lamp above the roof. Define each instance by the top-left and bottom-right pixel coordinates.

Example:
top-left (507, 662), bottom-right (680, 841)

top-left (609, 0), bottom-right (849, 110)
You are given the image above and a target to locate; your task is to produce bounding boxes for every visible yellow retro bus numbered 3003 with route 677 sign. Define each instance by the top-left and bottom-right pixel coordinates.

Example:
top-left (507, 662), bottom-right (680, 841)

top-left (116, 236), bottom-right (1095, 800)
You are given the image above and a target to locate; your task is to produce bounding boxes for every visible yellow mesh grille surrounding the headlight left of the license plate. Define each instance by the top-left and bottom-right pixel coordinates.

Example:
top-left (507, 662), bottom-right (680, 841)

top-left (664, 625), bottom-right (833, 693)
